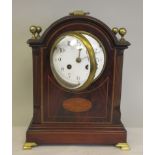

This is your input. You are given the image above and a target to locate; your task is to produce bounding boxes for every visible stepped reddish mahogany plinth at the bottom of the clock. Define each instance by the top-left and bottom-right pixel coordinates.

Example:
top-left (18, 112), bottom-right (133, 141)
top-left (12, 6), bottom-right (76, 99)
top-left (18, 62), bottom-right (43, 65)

top-left (26, 123), bottom-right (127, 149)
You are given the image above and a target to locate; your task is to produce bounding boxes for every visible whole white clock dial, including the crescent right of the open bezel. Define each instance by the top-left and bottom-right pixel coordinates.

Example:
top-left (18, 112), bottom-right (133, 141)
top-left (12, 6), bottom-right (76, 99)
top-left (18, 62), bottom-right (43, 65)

top-left (50, 33), bottom-right (105, 89)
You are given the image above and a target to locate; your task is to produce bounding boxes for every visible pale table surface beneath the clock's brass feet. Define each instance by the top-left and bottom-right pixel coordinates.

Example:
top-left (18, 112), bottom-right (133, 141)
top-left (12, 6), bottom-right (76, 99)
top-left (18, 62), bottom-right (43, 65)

top-left (12, 126), bottom-right (143, 155)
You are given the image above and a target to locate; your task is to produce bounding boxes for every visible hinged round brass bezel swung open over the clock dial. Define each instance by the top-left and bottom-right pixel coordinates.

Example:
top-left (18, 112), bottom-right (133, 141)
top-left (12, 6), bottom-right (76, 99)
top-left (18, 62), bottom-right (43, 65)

top-left (50, 31), bottom-right (97, 91)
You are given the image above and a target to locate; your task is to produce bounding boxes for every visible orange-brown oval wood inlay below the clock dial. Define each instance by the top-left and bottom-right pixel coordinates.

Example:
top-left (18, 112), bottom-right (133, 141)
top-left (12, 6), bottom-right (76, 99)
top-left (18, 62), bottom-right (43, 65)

top-left (63, 98), bottom-right (92, 112)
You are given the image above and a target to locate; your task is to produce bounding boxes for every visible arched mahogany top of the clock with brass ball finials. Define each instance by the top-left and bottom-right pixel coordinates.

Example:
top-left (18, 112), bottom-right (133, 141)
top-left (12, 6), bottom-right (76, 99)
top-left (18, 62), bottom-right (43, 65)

top-left (27, 14), bottom-right (130, 50)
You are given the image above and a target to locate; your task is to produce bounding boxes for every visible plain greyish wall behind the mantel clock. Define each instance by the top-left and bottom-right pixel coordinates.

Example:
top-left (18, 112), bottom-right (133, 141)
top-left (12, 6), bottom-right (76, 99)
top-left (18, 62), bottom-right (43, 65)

top-left (13, 0), bottom-right (143, 127)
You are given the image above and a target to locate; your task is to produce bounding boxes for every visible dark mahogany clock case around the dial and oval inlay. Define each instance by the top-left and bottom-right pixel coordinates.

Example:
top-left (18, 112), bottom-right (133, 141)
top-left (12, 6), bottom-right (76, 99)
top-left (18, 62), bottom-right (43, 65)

top-left (26, 16), bottom-right (130, 144)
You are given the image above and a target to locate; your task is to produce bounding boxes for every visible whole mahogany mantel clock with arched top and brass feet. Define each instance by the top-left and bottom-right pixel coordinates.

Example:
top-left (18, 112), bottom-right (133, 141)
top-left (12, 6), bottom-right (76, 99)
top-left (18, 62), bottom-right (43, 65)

top-left (24, 11), bottom-right (130, 149)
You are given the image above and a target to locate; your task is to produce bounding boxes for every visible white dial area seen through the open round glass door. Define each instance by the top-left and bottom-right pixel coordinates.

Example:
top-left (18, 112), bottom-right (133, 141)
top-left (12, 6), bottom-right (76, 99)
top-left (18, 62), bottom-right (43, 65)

top-left (51, 36), bottom-right (90, 87)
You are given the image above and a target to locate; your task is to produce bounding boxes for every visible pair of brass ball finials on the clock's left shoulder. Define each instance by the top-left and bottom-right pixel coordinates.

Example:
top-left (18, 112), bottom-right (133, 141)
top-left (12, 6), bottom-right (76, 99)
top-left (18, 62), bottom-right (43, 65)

top-left (30, 25), bottom-right (42, 39)
